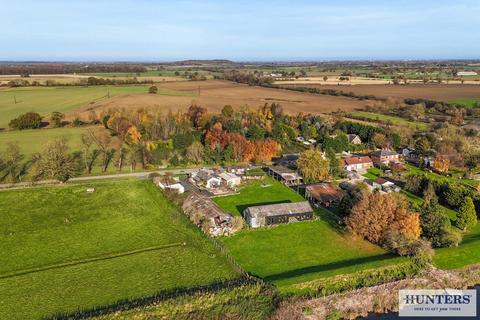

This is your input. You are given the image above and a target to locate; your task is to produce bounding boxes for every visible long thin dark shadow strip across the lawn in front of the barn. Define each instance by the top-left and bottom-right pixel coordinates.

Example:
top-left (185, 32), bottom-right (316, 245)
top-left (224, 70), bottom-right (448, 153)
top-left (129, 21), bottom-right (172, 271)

top-left (263, 253), bottom-right (394, 281)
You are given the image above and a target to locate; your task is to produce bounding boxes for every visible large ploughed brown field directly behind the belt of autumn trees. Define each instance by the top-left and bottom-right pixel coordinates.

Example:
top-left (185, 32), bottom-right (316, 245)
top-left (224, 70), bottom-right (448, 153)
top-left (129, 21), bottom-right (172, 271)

top-left (69, 80), bottom-right (369, 116)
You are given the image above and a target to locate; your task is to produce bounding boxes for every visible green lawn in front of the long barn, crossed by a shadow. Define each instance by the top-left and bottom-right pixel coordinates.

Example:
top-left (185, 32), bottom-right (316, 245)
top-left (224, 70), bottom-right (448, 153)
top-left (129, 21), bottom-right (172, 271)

top-left (222, 211), bottom-right (404, 291)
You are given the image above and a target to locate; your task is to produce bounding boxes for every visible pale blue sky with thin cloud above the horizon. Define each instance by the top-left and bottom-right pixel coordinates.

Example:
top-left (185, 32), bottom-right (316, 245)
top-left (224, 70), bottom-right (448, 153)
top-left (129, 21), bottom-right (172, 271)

top-left (0, 0), bottom-right (480, 62)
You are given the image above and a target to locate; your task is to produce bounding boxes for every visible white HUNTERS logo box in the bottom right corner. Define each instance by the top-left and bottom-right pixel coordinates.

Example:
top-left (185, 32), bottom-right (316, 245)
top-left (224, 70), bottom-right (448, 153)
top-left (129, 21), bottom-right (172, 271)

top-left (398, 289), bottom-right (477, 317)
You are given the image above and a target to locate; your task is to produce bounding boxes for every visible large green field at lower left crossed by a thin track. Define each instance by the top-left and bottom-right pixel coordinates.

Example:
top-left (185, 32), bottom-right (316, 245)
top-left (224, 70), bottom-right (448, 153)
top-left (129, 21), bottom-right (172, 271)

top-left (0, 180), bottom-right (237, 319)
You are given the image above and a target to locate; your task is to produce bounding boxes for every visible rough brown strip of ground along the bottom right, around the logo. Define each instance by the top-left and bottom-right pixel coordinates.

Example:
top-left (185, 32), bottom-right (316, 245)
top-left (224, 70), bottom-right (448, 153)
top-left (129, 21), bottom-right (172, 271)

top-left (271, 265), bottom-right (480, 320)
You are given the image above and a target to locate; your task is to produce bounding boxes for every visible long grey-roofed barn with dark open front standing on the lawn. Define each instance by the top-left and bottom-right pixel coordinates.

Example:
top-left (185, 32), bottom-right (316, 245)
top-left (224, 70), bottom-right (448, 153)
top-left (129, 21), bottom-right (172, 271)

top-left (243, 201), bottom-right (313, 228)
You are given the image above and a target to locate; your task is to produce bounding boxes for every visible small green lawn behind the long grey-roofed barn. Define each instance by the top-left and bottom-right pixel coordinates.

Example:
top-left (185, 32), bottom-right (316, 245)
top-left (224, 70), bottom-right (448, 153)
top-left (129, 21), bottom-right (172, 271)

top-left (213, 177), bottom-right (305, 216)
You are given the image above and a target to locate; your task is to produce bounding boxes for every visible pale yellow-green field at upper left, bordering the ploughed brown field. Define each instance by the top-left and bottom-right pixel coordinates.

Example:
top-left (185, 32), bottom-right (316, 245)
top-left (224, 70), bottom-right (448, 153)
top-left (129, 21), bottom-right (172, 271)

top-left (0, 85), bottom-right (190, 128)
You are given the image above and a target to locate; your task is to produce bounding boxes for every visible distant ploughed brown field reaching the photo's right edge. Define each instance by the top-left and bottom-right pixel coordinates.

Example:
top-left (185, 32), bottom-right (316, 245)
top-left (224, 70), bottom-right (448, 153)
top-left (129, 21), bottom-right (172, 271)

top-left (280, 84), bottom-right (480, 101)
